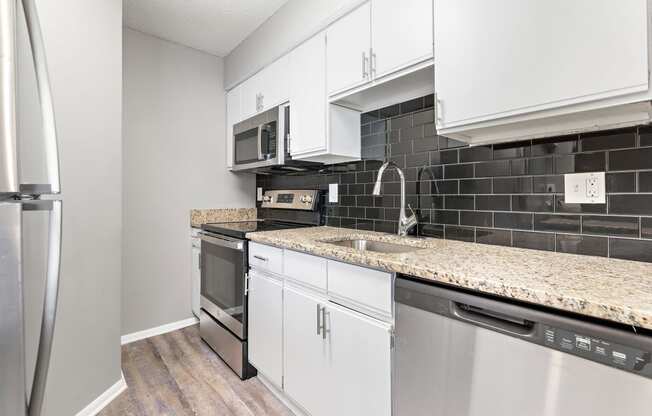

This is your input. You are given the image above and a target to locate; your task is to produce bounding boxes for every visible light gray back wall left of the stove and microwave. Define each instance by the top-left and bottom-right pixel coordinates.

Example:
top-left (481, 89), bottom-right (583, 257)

top-left (122, 29), bottom-right (255, 334)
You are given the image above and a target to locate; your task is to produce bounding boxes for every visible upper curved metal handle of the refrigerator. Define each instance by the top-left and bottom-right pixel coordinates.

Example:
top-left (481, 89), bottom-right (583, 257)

top-left (22, 0), bottom-right (61, 194)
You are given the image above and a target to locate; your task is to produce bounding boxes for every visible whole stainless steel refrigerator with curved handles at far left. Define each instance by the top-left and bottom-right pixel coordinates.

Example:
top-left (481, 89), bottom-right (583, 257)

top-left (0, 0), bottom-right (62, 416)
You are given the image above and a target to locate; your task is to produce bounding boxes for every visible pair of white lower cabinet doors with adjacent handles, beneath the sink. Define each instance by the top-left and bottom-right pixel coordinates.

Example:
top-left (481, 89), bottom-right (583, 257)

top-left (285, 287), bottom-right (392, 416)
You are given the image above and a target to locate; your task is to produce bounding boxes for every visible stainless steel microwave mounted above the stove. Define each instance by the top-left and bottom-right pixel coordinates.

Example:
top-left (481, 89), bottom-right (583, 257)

top-left (232, 104), bottom-right (321, 173)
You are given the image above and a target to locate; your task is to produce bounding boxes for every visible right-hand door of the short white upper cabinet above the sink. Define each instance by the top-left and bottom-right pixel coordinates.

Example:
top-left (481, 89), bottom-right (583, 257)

top-left (371, 0), bottom-right (433, 77)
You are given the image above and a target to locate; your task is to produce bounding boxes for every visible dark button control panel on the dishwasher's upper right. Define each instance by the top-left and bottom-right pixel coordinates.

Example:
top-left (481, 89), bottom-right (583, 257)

top-left (543, 325), bottom-right (652, 378)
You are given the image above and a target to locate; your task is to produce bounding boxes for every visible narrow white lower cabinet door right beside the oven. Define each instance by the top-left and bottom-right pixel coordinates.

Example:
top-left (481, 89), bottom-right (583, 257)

top-left (248, 271), bottom-right (283, 387)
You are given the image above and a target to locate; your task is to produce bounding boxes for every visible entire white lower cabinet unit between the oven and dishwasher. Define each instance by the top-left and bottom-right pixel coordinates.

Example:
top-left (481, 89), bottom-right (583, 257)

top-left (249, 243), bottom-right (393, 416)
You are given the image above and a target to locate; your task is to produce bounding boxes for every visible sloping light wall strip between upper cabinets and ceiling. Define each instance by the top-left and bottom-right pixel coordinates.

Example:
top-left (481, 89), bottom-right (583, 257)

top-left (224, 0), bottom-right (364, 89)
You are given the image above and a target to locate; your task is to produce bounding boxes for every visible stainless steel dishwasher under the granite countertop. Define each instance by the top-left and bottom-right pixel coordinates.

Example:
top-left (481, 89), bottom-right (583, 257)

top-left (394, 278), bottom-right (652, 416)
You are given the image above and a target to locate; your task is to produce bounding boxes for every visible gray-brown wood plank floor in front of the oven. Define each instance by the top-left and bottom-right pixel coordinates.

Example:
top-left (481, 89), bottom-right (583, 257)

top-left (99, 326), bottom-right (292, 416)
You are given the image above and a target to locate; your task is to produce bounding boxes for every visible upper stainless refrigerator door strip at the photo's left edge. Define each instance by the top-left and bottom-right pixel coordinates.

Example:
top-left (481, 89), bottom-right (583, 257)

top-left (0, 0), bottom-right (18, 194)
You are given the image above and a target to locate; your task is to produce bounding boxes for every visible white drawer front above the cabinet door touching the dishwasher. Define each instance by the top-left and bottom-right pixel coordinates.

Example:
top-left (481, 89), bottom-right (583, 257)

top-left (328, 260), bottom-right (392, 317)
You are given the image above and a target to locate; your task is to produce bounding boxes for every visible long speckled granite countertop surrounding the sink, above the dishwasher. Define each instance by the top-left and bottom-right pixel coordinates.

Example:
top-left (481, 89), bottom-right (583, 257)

top-left (247, 227), bottom-right (652, 329)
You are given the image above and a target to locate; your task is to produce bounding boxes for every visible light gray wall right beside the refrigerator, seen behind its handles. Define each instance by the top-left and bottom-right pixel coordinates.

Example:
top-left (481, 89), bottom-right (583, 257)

top-left (18, 0), bottom-right (122, 416)
